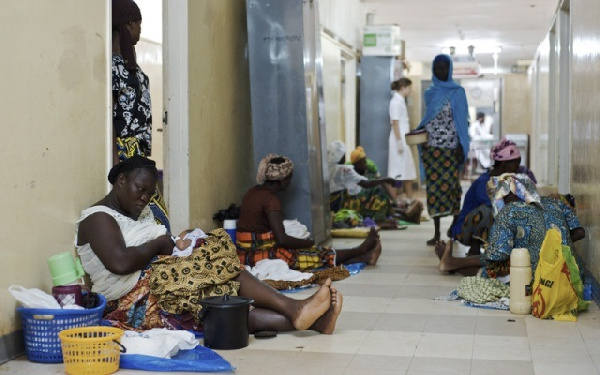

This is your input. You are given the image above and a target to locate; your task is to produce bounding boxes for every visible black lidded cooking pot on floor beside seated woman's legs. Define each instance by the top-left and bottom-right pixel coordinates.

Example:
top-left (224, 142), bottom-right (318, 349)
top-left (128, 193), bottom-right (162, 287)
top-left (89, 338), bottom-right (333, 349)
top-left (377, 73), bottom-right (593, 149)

top-left (200, 294), bottom-right (254, 349)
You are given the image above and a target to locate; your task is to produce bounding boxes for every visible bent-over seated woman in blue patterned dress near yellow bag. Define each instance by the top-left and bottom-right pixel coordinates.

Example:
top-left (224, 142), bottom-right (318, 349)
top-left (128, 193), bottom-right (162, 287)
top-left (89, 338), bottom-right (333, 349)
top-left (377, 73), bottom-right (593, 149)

top-left (438, 173), bottom-right (585, 277)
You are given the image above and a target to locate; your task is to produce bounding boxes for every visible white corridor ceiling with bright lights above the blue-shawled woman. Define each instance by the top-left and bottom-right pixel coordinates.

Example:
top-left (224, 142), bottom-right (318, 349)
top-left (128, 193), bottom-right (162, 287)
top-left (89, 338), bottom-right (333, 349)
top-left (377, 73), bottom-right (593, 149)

top-left (361, 0), bottom-right (560, 73)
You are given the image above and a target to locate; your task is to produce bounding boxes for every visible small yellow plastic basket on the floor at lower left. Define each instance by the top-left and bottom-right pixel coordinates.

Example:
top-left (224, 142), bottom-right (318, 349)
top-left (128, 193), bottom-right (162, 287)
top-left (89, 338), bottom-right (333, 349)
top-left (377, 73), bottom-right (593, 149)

top-left (58, 326), bottom-right (123, 375)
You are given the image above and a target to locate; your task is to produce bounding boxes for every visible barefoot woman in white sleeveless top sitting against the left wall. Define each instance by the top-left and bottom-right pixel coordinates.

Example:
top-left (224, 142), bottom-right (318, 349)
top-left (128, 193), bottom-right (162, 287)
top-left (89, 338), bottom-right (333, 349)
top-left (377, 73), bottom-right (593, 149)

top-left (75, 155), bottom-right (342, 334)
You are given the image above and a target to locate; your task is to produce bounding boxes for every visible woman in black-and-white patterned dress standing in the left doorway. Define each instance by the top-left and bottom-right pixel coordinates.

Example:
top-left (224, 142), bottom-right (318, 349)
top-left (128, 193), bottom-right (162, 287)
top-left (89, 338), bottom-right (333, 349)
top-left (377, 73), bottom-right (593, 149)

top-left (112, 0), bottom-right (170, 231)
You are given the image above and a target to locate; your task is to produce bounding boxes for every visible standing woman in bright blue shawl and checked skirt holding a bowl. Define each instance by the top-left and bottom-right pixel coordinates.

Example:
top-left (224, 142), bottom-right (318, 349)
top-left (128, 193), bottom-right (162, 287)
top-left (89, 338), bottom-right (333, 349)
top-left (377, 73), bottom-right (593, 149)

top-left (417, 55), bottom-right (469, 246)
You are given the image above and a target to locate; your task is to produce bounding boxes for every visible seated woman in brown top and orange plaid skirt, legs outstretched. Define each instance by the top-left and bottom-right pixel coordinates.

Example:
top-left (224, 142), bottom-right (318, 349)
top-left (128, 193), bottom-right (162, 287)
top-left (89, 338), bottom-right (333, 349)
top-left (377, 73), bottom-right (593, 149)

top-left (236, 154), bottom-right (381, 270)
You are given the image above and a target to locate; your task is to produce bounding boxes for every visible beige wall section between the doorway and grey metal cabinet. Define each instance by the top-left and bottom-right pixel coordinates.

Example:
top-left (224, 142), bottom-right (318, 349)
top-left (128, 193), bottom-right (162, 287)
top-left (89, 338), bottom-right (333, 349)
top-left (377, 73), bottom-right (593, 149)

top-left (188, 0), bottom-right (254, 229)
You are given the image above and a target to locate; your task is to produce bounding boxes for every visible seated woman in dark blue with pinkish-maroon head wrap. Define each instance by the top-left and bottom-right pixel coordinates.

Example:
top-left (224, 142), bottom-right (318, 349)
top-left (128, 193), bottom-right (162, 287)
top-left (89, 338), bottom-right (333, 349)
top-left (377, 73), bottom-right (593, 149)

top-left (448, 138), bottom-right (521, 255)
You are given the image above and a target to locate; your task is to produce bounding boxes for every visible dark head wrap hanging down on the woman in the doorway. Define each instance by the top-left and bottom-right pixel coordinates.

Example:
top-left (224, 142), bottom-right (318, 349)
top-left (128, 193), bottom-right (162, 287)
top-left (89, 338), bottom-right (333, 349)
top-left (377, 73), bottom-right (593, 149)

top-left (112, 0), bottom-right (142, 71)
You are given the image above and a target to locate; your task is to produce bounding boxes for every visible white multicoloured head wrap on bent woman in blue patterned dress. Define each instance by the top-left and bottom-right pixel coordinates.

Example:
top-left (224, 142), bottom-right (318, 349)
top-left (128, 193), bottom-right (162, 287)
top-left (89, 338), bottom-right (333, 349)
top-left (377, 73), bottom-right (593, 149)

top-left (487, 173), bottom-right (541, 216)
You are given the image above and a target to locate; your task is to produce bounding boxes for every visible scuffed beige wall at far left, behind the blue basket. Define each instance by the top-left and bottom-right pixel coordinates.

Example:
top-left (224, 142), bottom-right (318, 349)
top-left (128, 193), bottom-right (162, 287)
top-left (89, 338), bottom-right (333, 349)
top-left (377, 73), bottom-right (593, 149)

top-left (0, 0), bottom-right (110, 335)
